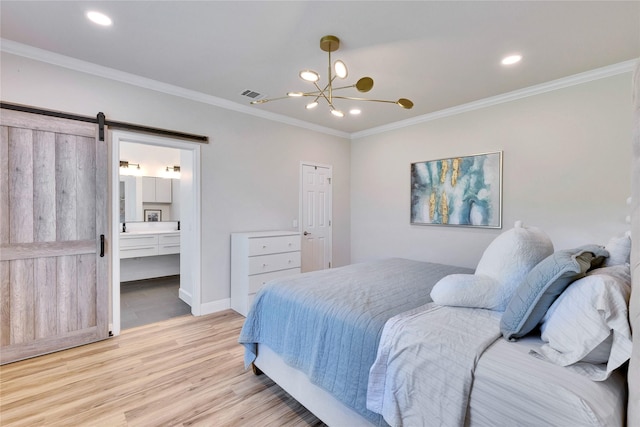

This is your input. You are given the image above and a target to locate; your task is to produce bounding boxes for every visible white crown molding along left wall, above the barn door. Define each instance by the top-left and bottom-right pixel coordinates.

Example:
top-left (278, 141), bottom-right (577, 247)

top-left (0, 38), bottom-right (350, 139)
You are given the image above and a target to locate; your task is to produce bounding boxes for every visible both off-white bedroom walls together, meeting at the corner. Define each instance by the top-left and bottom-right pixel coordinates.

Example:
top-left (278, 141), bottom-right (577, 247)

top-left (5, 53), bottom-right (632, 303)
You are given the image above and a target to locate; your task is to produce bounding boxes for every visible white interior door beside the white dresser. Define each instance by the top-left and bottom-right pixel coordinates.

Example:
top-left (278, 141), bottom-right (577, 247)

top-left (301, 163), bottom-right (332, 273)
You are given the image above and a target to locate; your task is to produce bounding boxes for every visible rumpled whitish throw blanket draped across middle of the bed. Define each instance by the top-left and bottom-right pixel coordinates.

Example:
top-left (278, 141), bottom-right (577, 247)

top-left (367, 303), bottom-right (500, 427)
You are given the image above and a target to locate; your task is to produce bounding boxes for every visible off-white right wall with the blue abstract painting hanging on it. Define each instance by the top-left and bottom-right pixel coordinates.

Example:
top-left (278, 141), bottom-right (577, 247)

top-left (351, 73), bottom-right (632, 267)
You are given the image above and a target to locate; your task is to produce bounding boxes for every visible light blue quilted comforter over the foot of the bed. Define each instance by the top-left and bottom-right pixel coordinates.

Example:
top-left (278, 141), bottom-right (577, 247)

top-left (239, 258), bottom-right (472, 425)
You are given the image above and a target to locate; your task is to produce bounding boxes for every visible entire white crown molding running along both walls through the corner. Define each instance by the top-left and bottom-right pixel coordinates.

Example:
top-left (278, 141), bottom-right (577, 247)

top-left (0, 38), bottom-right (637, 140)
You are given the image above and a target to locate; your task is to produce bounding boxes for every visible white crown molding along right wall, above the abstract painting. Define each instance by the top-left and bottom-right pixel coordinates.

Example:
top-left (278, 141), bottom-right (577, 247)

top-left (351, 59), bottom-right (638, 140)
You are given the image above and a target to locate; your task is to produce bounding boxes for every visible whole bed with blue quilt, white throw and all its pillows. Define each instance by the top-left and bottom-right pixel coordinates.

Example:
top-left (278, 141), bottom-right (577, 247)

top-left (239, 61), bottom-right (640, 426)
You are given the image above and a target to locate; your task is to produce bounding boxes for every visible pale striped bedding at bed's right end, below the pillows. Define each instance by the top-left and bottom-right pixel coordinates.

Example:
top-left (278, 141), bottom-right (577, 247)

top-left (465, 337), bottom-right (626, 427)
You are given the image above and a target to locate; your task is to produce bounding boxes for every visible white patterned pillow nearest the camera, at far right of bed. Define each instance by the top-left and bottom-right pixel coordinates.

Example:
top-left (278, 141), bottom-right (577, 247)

top-left (540, 264), bottom-right (631, 381)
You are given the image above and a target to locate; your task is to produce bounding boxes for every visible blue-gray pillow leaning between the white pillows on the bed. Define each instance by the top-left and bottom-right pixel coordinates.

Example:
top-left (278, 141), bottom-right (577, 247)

top-left (500, 245), bottom-right (609, 340)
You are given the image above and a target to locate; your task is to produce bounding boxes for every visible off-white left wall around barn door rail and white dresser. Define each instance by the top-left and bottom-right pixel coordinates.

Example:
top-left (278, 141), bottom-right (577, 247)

top-left (0, 52), bottom-right (351, 304)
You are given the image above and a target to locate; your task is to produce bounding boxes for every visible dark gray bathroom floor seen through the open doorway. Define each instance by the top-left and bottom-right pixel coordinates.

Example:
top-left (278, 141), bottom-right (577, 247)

top-left (120, 276), bottom-right (191, 330)
